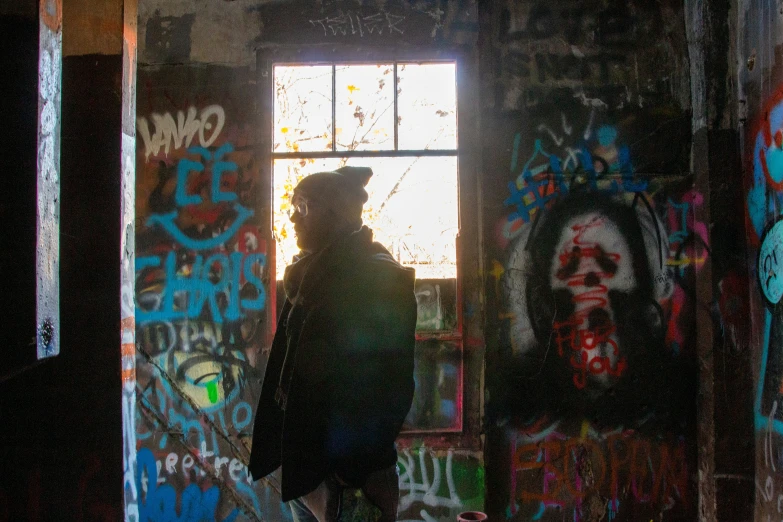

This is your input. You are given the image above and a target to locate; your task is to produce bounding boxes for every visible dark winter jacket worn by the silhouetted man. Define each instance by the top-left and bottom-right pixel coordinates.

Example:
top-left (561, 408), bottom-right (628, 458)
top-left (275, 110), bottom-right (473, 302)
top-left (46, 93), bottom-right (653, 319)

top-left (249, 227), bottom-right (416, 501)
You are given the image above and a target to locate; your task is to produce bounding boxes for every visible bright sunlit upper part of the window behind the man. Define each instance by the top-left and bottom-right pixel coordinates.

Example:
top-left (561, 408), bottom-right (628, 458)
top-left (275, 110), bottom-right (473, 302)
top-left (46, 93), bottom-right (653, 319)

top-left (272, 62), bottom-right (458, 279)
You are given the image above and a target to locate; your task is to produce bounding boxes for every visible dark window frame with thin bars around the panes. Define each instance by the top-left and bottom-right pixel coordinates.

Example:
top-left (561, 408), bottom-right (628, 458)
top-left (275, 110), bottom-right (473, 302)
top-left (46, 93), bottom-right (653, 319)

top-left (257, 46), bottom-right (483, 438)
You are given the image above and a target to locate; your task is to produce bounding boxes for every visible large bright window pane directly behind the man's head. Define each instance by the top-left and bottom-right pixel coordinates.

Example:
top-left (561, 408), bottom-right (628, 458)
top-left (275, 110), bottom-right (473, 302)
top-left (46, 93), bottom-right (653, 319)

top-left (274, 157), bottom-right (458, 279)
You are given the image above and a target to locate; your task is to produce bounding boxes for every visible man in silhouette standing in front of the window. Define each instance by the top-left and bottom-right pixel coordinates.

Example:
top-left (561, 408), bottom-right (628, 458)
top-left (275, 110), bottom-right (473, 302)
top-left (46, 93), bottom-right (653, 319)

top-left (249, 167), bottom-right (416, 522)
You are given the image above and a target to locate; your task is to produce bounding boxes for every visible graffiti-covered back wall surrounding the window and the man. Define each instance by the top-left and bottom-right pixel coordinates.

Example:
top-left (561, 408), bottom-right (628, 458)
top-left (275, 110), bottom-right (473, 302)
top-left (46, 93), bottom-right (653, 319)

top-left (136, 0), bottom-right (728, 521)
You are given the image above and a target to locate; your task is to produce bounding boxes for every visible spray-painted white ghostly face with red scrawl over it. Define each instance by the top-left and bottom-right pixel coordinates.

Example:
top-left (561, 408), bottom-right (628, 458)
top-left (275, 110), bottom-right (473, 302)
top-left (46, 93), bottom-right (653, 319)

top-left (549, 212), bottom-right (637, 389)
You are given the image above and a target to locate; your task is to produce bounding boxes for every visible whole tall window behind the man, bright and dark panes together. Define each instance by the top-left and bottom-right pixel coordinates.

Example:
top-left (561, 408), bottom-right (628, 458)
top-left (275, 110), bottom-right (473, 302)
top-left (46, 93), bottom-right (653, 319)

top-left (270, 61), bottom-right (463, 432)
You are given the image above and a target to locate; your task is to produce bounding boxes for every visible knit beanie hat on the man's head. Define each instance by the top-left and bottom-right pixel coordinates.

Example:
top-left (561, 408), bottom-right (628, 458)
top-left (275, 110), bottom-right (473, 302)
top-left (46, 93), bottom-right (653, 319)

top-left (296, 167), bottom-right (372, 225)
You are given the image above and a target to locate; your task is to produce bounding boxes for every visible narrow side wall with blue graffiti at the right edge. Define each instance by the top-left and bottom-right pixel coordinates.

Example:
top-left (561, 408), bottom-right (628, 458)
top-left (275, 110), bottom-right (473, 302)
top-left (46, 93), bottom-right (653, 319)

top-left (738, 0), bottom-right (783, 520)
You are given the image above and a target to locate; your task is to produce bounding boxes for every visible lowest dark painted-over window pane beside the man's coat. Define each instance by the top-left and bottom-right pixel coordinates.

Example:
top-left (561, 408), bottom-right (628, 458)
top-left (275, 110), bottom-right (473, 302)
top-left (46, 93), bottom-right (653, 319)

top-left (403, 340), bottom-right (462, 431)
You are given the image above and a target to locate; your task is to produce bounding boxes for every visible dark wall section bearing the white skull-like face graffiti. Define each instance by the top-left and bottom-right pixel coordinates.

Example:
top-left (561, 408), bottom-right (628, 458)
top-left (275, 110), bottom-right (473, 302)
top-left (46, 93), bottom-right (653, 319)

top-left (482, 1), bottom-right (710, 521)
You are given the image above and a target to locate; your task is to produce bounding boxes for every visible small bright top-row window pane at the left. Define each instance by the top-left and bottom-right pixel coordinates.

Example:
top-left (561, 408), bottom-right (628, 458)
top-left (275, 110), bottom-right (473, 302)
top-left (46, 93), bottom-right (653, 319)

top-left (273, 65), bottom-right (332, 152)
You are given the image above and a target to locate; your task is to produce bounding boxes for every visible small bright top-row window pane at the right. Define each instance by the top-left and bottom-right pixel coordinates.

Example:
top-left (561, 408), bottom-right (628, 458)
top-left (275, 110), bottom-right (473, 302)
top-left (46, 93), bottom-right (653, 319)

top-left (397, 63), bottom-right (457, 150)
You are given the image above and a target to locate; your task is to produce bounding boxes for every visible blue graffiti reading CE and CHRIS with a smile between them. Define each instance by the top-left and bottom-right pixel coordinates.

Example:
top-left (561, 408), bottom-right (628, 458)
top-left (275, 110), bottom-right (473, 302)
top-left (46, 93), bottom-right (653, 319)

top-left (136, 143), bottom-right (266, 323)
